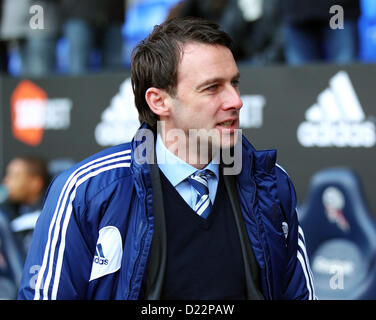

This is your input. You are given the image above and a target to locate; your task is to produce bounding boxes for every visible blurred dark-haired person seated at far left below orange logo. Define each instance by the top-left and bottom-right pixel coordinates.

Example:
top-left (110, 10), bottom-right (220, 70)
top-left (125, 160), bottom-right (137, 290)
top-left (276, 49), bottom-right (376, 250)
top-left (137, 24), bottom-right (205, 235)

top-left (0, 156), bottom-right (49, 254)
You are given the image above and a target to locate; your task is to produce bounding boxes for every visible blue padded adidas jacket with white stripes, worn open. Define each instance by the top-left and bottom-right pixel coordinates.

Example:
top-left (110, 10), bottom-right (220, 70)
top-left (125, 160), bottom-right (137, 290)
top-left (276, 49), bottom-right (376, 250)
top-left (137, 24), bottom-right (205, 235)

top-left (18, 125), bottom-right (316, 300)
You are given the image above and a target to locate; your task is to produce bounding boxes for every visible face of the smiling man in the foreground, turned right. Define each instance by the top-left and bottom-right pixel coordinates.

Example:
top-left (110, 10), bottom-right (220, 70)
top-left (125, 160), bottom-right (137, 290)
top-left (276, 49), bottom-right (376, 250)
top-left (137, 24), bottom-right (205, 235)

top-left (166, 42), bottom-right (242, 151)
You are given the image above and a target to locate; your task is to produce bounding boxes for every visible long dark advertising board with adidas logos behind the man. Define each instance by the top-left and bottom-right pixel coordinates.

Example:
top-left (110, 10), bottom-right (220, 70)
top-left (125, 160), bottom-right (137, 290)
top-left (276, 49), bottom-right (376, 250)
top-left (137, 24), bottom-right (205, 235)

top-left (0, 65), bottom-right (376, 220)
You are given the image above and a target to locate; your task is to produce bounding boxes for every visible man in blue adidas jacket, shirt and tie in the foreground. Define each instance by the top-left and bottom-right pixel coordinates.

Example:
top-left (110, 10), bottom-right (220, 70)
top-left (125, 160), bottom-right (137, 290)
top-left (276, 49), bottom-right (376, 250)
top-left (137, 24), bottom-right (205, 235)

top-left (19, 18), bottom-right (315, 300)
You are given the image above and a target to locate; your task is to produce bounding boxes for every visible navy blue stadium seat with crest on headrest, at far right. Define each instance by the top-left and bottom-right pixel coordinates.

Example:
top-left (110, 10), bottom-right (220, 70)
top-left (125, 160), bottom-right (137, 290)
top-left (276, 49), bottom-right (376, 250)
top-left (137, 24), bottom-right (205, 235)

top-left (299, 168), bottom-right (376, 300)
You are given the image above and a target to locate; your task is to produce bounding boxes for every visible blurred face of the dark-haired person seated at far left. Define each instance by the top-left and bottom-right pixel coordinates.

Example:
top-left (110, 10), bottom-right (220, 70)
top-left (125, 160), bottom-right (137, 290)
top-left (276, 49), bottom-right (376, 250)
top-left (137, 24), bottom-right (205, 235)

top-left (4, 159), bottom-right (33, 203)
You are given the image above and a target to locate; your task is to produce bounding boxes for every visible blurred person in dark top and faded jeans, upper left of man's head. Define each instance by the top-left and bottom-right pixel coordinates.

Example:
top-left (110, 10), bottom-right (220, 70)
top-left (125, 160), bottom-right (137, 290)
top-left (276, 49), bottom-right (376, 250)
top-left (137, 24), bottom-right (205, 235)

top-left (59, 0), bottom-right (126, 74)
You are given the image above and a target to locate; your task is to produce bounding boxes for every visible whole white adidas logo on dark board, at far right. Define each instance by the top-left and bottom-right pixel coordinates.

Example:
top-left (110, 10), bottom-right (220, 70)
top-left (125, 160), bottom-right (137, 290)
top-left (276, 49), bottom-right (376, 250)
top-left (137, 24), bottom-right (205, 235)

top-left (297, 71), bottom-right (376, 148)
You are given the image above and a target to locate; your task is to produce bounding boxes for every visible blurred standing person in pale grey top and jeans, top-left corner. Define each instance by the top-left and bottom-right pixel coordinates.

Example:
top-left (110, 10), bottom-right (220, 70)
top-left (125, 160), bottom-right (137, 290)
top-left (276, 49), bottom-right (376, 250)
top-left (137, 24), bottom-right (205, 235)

top-left (0, 0), bottom-right (60, 76)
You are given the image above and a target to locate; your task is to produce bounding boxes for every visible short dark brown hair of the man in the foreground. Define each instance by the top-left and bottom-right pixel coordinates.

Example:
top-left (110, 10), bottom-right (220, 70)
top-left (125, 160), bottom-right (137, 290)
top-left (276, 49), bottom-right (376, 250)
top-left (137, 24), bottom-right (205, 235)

top-left (131, 17), bottom-right (233, 128)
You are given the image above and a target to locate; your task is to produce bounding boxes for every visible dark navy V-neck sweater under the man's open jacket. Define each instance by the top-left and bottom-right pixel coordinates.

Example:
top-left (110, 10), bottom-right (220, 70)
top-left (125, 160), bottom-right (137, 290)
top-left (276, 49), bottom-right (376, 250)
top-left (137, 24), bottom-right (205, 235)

top-left (160, 172), bottom-right (246, 300)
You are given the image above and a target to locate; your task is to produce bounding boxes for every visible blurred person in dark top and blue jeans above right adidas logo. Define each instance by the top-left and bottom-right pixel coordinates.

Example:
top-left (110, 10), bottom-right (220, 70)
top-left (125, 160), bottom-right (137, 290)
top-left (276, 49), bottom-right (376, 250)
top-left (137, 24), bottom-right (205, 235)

top-left (282, 0), bottom-right (360, 65)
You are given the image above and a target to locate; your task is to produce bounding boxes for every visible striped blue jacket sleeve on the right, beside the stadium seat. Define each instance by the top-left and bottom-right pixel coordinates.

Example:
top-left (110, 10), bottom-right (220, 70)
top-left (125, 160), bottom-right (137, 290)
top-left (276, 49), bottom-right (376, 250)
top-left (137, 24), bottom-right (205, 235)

top-left (277, 165), bottom-right (317, 300)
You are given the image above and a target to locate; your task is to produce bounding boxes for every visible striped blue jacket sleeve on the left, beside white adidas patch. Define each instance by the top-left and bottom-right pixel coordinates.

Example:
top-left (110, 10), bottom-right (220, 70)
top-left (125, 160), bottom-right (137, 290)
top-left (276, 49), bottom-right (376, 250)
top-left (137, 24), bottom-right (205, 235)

top-left (18, 172), bottom-right (93, 300)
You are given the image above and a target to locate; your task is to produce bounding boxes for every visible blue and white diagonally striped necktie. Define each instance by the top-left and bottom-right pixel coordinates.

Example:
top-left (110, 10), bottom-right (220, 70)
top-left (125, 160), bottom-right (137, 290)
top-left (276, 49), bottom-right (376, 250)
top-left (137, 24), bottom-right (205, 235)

top-left (187, 170), bottom-right (213, 218)
